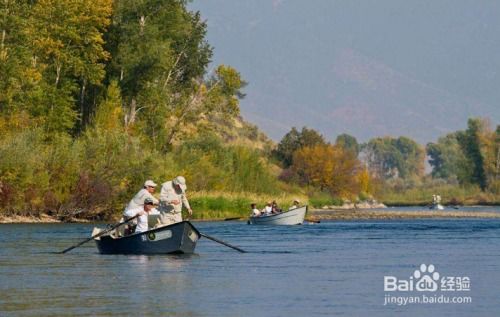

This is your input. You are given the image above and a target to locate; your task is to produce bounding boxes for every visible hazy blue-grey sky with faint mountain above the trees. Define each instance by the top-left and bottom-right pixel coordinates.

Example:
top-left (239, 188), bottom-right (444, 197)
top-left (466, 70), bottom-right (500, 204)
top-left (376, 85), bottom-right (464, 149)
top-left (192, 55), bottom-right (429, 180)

top-left (190, 0), bottom-right (500, 144)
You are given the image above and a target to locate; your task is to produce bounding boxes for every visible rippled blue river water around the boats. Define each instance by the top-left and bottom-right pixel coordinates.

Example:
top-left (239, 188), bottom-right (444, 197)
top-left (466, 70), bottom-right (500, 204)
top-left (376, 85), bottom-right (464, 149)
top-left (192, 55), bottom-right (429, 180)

top-left (0, 219), bottom-right (500, 317)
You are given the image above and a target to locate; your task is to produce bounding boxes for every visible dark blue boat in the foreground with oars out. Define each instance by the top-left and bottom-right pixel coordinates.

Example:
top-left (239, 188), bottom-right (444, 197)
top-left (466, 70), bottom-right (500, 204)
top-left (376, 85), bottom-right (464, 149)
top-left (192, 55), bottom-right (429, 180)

top-left (94, 221), bottom-right (201, 254)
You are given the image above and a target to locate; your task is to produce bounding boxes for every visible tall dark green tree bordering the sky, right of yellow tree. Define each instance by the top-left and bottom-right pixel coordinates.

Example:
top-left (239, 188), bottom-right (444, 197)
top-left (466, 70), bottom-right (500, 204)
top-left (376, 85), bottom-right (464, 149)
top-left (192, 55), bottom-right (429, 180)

top-left (107, 0), bottom-right (212, 138)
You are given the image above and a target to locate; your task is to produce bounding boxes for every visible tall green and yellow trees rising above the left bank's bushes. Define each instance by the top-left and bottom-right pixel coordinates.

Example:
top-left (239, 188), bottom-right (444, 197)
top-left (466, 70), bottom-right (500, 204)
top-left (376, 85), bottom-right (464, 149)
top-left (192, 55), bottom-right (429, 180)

top-left (0, 0), bottom-right (244, 141)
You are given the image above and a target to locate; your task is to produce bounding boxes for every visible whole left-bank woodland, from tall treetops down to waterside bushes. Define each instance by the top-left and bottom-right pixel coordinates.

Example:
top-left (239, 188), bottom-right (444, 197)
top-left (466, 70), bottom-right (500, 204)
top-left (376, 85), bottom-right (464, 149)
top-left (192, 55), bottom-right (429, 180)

top-left (0, 0), bottom-right (279, 218)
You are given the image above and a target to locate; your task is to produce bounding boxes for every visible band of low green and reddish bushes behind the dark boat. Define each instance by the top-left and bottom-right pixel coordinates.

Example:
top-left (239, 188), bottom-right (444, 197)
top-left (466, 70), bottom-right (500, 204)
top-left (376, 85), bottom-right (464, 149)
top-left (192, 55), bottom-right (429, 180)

top-left (0, 127), bottom-right (291, 219)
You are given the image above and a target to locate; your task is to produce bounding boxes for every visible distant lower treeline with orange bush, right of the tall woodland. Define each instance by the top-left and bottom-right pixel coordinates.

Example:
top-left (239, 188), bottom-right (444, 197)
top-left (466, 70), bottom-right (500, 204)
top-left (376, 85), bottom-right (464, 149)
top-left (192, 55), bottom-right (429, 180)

top-left (273, 118), bottom-right (500, 203)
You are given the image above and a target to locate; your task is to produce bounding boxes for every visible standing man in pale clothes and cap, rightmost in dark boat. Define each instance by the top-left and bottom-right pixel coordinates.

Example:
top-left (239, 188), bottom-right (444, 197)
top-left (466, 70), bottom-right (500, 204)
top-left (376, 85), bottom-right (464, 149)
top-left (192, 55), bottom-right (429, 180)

top-left (159, 176), bottom-right (193, 226)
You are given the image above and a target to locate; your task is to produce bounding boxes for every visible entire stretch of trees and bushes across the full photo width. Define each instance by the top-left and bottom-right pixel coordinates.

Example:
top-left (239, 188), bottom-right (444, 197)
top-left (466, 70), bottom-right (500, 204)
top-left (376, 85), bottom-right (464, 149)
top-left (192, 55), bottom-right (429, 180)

top-left (0, 0), bottom-right (500, 218)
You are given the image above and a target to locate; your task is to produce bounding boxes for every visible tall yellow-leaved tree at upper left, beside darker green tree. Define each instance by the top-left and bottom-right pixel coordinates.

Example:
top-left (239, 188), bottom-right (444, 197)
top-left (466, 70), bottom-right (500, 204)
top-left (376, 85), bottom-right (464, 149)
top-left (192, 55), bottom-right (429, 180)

top-left (26, 0), bottom-right (112, 132)
